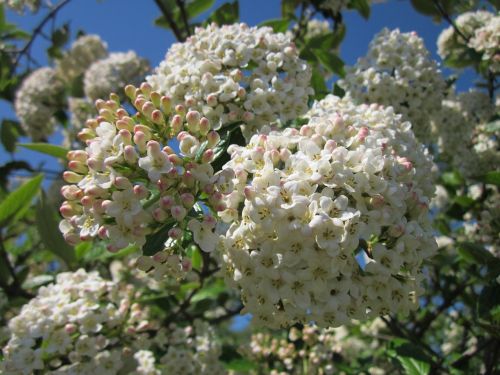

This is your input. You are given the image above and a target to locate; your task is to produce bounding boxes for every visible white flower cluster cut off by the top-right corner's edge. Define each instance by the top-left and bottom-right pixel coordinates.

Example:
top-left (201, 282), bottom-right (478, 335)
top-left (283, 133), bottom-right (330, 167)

top-left (437, 10), bottom-right (500, 72)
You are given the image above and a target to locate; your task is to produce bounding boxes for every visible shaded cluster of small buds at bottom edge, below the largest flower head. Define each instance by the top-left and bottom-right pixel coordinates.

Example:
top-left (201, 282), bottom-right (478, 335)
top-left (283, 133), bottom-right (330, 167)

top-left (246, 319), bottom-right (384, 375)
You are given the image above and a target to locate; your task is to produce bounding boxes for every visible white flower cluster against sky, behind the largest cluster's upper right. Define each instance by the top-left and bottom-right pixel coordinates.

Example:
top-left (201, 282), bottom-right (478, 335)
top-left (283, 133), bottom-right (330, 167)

top-left (339, 29), bottom-right (446, 142)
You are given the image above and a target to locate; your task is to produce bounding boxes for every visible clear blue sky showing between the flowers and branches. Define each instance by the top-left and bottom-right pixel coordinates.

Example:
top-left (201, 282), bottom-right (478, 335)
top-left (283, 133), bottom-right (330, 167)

top-left (0, 0), bottom-right (471, 167)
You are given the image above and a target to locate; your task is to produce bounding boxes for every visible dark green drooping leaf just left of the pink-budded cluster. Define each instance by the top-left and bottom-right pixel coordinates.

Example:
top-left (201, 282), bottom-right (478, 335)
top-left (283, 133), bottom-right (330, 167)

top-left (36, 194), bottom-right (76, 268)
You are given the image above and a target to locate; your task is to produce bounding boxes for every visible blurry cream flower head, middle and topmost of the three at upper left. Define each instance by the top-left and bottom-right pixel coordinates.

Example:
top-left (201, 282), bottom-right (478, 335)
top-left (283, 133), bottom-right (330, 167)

top-left (56, 35), bottom-right (109, 83)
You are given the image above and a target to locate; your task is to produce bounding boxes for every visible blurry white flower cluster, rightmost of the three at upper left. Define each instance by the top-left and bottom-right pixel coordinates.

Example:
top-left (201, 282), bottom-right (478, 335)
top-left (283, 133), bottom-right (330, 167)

top-left (83, 51), bottom-right (150, 101)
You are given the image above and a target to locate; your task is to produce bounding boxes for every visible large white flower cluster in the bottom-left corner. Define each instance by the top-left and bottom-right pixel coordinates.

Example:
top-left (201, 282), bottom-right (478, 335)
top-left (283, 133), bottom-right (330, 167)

top-left (0, 269), bottom-right (149, 375)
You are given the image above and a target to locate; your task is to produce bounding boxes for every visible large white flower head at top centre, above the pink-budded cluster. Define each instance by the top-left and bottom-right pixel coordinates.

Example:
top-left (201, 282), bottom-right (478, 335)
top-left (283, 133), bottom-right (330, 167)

top-left (147, 24), bottom-right (312, 140)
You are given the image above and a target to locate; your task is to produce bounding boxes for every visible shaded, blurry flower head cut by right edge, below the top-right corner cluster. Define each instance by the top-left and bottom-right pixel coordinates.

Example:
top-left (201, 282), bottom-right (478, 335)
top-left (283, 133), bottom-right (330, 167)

top-left (432, 90), bottom-right (500, 177)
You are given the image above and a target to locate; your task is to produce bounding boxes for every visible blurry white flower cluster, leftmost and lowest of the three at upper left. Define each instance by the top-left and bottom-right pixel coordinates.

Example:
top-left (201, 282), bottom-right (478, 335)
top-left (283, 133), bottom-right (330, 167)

top-left (14, 67), bottom-right (64, 141)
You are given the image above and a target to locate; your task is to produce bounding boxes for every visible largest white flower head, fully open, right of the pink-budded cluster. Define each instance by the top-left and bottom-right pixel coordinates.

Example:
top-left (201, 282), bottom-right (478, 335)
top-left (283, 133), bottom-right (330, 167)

top-left (220, 96), bottom-right (436, 328)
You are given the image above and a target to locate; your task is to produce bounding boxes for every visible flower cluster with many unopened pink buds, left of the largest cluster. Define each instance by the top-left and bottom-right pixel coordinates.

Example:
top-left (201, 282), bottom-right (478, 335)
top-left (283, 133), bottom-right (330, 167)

top-left (60, 83), bottom-right (234, 280)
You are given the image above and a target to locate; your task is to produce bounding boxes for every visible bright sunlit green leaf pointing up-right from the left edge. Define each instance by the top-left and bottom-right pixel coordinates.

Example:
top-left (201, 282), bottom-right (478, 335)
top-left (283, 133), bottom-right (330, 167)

top-left (0, 174), bottom-right (43, 226)
